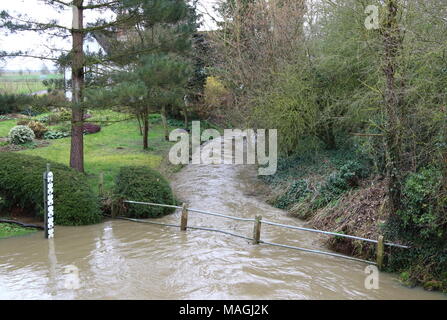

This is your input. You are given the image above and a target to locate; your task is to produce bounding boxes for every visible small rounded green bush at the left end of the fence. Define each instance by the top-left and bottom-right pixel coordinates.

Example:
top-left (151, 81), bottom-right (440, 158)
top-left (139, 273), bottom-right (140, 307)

top-left (114, 167), bottom-right (175, 218)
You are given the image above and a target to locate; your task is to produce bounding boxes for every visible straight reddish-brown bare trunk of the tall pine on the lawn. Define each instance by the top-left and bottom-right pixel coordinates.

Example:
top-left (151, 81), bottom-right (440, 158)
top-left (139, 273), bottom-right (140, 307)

top-left (70, 0), bottom-right (84, 172)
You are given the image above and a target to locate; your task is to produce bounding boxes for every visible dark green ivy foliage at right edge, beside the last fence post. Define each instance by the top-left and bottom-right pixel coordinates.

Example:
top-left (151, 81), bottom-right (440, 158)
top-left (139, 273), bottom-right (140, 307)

top-left (384, 166), bottom-right (447, 291)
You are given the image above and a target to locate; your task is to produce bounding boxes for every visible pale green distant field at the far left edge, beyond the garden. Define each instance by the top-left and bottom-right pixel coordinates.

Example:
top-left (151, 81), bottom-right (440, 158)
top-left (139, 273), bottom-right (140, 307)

top-left (0, 72), bottom-right (62, 94)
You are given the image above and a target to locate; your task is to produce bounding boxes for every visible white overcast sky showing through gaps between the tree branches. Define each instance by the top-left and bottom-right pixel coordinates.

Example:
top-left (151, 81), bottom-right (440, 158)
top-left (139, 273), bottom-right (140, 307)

top-left (0, 0), bottom-right (218, 70)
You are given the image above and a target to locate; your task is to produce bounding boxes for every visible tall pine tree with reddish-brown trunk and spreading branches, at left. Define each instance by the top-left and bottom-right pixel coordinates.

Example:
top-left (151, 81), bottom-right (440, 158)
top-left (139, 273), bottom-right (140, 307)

top-left (0, 0), bottom-right (198, 172)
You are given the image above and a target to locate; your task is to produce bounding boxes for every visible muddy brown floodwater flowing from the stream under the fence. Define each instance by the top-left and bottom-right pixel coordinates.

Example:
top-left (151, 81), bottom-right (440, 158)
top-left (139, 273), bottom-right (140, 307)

top-left (0, 136), bottom-right (446, 299)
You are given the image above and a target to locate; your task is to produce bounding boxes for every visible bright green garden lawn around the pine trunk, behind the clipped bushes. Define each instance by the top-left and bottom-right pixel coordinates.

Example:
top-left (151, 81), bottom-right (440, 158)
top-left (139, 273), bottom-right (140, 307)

top-left (20, 120), bottom-right (176, 192)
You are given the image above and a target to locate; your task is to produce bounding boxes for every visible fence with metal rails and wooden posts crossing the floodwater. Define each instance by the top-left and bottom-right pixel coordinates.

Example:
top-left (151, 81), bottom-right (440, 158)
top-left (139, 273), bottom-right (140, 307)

top-left (120, 200), bottom-right (410, 268)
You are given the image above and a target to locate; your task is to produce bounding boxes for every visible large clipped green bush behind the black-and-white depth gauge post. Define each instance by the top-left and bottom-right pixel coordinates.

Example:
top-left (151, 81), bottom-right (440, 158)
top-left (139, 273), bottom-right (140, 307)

top-left (0, 152), bottom-right (101, 225)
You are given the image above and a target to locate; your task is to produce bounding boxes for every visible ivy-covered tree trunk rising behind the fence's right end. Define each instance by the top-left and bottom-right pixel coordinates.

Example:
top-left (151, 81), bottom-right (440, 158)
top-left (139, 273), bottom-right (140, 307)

top-left (382, 0), bottom-right (404, 213)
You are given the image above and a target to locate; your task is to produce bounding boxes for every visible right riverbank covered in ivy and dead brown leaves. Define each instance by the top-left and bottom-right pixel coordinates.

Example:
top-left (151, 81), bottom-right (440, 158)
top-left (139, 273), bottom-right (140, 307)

top-left (263, 150), bottom-right (447, 292)
